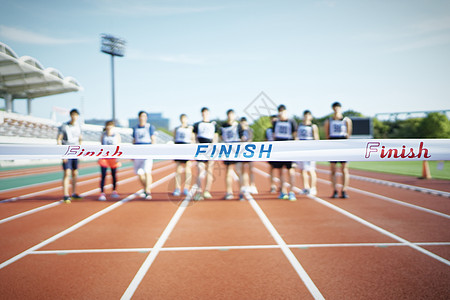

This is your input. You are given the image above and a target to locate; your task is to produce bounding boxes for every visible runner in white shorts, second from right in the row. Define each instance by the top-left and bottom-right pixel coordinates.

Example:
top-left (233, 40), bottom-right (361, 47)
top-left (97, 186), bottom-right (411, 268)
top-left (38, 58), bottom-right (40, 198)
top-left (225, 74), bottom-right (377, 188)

top-left (297, 110), bottom-right (319, 195)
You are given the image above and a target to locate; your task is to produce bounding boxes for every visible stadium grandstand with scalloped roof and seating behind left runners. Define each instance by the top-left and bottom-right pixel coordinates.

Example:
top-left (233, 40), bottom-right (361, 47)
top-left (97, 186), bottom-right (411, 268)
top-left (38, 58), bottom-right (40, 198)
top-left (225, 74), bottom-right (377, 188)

top-left (0, 42), bottom-right (172, 163)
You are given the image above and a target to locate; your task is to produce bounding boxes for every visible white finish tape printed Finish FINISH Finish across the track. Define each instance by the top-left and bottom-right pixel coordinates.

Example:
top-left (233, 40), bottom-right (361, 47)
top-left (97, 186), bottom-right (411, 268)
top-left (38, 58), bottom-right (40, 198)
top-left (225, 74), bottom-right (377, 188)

top-left (0, 139), bottom-right (450, 161)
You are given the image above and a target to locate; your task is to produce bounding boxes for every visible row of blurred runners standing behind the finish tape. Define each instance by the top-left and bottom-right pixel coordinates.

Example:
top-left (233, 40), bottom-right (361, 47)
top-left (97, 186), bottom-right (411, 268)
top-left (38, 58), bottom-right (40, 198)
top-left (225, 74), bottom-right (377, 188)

top-left (57, 102), bottom-right (352, 203)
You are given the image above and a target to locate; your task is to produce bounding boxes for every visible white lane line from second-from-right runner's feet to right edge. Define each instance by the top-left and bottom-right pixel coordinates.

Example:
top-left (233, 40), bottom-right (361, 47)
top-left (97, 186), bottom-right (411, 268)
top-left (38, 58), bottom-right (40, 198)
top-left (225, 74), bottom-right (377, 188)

top-left (307, 195), bottom-right (450, 266)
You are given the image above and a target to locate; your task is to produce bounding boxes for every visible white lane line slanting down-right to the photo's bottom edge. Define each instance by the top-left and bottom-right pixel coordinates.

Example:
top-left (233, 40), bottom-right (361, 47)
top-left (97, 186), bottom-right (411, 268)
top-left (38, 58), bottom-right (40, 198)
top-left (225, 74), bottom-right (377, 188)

top-left (245, 193), bottom-right (325, 299)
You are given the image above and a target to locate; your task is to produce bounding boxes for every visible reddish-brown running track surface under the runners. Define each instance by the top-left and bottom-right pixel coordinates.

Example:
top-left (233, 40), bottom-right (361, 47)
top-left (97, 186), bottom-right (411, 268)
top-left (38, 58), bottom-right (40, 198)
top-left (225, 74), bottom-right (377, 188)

top-left (0, 161), bottom-right (450, 299)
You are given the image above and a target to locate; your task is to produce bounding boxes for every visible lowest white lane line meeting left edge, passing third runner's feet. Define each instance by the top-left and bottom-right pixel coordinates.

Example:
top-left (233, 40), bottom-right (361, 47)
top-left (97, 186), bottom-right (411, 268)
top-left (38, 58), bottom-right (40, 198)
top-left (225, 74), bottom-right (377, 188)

top-left (0, 173), bottom-right (174, 270)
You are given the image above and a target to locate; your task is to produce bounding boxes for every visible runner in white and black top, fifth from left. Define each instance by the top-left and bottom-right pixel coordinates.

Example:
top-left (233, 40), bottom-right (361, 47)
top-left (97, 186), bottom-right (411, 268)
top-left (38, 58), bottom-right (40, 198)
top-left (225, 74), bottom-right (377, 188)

top-left (193, 107), bottom-right (219, 200)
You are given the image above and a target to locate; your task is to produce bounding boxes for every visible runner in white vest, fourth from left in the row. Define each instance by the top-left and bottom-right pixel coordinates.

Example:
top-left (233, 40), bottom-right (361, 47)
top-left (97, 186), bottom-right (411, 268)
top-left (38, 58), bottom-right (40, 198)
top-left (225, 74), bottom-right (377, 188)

top-left (173, 114), bottom-right (194, 196)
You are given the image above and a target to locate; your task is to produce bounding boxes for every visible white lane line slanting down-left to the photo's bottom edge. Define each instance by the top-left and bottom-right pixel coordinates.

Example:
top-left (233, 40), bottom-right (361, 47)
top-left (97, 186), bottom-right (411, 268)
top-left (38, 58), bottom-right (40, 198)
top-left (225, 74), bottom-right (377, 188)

top-left (121, 193), bottom-right (194, 300)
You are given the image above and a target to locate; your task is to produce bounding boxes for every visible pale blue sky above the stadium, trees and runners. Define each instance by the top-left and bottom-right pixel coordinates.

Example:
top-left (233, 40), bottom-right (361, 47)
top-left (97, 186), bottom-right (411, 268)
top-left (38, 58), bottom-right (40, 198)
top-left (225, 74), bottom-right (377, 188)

top-left (0, 0), bottom-right (450, 127)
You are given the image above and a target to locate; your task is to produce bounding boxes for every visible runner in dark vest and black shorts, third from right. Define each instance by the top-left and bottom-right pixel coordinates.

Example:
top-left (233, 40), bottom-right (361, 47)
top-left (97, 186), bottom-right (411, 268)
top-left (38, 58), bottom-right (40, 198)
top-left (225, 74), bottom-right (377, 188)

top-left (273, 105), bottom-right (297, 201)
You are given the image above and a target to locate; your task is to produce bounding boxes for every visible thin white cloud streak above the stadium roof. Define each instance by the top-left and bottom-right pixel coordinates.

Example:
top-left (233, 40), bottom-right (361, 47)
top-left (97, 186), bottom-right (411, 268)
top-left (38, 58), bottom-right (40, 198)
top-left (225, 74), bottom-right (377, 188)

top-left (0, 25), bottom-right (86, 45)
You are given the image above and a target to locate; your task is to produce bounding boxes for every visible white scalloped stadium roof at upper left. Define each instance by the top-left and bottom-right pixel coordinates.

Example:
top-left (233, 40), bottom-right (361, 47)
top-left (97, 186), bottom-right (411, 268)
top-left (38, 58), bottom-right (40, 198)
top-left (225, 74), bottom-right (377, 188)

top-left (0, 42), bottom-right (83, 99)
